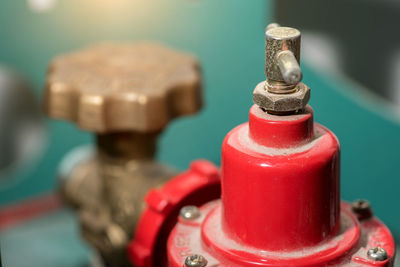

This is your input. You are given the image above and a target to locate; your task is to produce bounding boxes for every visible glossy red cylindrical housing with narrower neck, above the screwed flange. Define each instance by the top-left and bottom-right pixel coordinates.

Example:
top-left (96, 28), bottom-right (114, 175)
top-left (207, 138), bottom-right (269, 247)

top-left (221, 105), bottom-right (340, 251)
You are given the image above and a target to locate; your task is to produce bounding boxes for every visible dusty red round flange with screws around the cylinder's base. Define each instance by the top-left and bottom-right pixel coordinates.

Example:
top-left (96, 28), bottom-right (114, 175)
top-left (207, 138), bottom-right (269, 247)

top-left (168, 201), bottom-right (395, 267)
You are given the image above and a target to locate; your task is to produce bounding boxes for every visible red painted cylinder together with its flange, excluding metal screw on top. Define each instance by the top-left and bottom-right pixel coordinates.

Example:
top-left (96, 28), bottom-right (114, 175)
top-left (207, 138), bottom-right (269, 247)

top-left (164, 106), bottom-right (394, 267)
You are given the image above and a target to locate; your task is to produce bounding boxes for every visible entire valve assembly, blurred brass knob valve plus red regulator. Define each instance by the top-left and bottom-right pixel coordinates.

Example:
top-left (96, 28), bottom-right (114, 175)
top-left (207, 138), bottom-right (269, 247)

top-left (45, 24), bottom-right (395, 267)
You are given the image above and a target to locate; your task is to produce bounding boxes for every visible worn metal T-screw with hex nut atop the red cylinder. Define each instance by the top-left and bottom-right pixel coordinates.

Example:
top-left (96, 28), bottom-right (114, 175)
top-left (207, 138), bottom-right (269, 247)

top-left (253, 23), bottom-right (310, 115)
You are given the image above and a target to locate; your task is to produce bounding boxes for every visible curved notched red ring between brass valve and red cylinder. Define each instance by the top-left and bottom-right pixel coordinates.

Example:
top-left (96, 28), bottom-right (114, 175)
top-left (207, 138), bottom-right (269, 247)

top-left (127, 160), bottom-right (221, 267)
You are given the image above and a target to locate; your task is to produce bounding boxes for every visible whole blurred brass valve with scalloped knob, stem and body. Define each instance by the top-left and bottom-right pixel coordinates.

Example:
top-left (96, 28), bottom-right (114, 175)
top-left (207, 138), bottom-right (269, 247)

top-left (44, 43), bottom-right (201, 266)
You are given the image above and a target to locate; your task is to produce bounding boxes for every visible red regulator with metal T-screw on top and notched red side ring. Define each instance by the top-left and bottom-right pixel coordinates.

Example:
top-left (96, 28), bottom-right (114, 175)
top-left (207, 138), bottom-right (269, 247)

top-left (128, 24), bottom-right (395, 267)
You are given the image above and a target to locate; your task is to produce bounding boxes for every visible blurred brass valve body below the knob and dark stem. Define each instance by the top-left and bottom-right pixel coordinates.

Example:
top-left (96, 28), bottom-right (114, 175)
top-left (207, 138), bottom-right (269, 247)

top-left (62, 155), bottom-right (176, 266)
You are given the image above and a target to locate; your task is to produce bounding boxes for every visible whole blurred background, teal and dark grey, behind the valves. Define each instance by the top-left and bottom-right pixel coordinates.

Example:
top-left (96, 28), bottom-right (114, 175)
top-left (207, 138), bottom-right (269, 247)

top-left (0, 0), bottom-right (400, 266)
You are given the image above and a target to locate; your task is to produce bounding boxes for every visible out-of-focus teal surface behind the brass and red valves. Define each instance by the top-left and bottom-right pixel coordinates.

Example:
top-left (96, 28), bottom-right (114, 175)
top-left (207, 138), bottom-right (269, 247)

top-left (0, 0), bottom-right (400, 243)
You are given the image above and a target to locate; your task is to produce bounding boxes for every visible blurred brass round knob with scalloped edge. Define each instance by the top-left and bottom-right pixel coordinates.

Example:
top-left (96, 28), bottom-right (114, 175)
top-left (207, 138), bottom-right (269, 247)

top-left (44, 43), bottom-right (201, 133)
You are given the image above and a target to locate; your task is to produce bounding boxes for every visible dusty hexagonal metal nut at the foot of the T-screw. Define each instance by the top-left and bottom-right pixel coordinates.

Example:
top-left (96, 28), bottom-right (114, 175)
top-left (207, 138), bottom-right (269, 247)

top-left (253, 82), bottom-right (310, 113)
